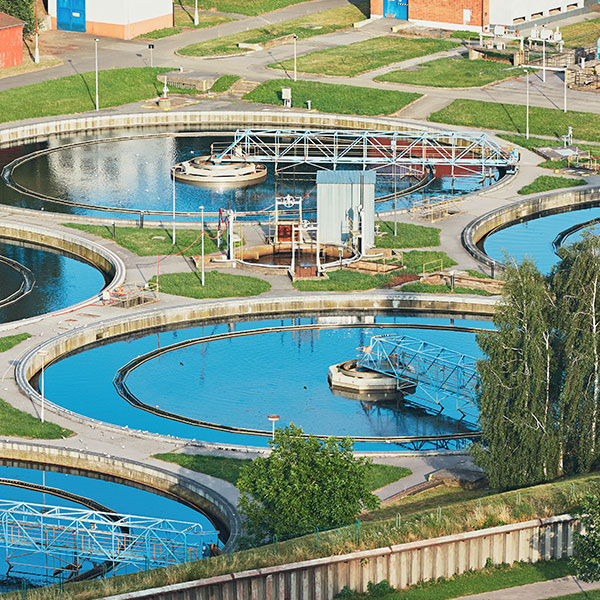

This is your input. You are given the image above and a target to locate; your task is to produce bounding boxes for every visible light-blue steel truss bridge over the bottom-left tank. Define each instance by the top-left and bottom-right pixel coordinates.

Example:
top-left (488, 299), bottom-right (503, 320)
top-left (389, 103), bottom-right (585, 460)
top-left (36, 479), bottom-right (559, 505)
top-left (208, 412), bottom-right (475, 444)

top-left (0, 500), bottom-right (218, 577)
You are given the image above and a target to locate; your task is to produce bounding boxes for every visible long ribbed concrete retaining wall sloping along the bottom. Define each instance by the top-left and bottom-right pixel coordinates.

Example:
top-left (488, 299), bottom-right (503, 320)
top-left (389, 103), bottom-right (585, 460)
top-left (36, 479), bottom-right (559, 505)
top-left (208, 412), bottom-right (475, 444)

top-left (105, 515), bottom-right (579, 600)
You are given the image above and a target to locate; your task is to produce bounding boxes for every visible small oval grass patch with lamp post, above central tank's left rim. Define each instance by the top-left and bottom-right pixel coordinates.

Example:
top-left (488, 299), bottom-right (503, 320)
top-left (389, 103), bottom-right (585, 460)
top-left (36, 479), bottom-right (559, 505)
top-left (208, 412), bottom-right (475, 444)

top-left (150, 271), bottom-right (271, 300)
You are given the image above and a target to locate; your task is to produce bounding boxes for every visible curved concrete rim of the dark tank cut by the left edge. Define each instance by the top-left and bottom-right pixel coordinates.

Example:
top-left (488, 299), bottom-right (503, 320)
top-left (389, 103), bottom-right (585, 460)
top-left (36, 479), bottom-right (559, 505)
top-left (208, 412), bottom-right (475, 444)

top-left (0, 223), bottom-right (126, 331)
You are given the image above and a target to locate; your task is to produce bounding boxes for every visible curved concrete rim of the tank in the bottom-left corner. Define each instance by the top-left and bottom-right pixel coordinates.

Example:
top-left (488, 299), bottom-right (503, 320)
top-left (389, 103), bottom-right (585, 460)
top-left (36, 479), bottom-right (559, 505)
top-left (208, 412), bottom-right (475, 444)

top-left (0, 440), bottom-right (240, 543)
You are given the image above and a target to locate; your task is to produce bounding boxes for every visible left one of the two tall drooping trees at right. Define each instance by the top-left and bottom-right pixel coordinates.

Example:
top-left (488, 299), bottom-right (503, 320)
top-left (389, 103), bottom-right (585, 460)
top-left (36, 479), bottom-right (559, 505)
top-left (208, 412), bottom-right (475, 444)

top-left (473, 260), bottom-right (560, 489)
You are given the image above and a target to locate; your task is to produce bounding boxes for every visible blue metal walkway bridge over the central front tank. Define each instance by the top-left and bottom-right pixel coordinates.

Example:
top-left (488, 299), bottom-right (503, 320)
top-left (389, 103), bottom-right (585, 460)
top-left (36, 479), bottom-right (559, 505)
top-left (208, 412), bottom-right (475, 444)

top-left (358, 334), bottom-right (479, 419)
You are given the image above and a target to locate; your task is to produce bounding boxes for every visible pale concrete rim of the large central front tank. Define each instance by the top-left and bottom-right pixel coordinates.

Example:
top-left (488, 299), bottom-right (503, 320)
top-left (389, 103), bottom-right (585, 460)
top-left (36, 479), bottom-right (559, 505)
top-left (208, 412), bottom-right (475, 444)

top-left (15, 292), bottom-right (496, 452)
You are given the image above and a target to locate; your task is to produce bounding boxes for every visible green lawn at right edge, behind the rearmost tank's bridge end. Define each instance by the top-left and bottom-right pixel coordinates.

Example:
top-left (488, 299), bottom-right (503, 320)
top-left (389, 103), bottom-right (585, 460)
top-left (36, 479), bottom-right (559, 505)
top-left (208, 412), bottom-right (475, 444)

top-left (429, 100), bottom-right (600, 142)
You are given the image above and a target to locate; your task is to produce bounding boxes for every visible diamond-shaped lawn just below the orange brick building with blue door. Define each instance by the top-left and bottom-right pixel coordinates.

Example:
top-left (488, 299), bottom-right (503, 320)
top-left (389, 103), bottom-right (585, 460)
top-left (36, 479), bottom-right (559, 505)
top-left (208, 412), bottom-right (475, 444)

top-left (269, 36), bottom-right (460, 77)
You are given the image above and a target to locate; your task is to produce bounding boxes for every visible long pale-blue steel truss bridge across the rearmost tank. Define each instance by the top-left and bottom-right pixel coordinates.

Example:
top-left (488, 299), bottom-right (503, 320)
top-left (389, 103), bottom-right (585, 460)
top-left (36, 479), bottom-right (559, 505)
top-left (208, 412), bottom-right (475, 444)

top-left (212, 129), bottom-right (519, 175)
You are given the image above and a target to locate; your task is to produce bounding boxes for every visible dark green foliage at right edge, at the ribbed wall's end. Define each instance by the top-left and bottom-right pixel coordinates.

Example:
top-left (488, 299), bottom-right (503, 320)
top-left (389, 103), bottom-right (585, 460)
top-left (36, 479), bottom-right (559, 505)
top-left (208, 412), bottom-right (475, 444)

top-left (572, 495), bottom-right (600, 581)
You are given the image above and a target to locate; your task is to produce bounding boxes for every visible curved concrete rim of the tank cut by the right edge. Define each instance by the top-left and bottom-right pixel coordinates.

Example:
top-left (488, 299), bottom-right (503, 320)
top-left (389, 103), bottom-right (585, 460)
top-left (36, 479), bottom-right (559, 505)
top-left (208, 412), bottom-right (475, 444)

top-left (461, 186), bottom-right (600, 271)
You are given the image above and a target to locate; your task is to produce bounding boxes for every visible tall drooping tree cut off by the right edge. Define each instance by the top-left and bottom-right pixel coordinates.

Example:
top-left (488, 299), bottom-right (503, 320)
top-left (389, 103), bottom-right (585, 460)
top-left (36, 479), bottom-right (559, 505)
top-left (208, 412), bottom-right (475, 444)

top-left (552, 233), bottom-right (600, 473)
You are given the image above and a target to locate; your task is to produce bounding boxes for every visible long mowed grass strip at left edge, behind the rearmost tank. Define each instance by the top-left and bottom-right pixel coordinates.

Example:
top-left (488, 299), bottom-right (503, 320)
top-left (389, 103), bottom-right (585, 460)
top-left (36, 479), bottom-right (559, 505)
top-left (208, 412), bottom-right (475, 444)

top-left (0, 67), bottom-right (171, 123)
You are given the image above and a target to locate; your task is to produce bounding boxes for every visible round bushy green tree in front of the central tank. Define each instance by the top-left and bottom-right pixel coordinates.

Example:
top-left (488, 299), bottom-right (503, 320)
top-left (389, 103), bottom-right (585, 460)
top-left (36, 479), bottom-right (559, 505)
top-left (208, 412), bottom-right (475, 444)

top-left (237, 423), bottom-right (379, 543)
